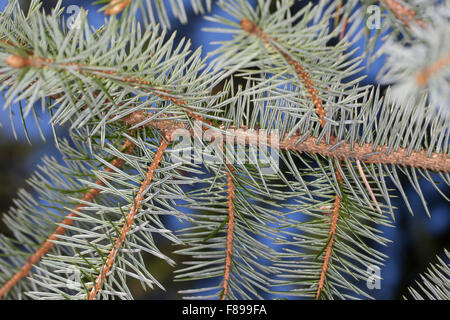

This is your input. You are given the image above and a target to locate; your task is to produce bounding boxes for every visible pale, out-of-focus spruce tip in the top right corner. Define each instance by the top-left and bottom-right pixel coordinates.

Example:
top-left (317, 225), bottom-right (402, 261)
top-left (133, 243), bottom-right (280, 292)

top-left (378, 2), bottom-right (450, 117)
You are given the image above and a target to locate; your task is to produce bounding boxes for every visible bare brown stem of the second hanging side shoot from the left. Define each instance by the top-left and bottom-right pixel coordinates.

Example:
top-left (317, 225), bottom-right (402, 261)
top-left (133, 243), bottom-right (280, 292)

top-left (88, 140), bottom-right (168, 300)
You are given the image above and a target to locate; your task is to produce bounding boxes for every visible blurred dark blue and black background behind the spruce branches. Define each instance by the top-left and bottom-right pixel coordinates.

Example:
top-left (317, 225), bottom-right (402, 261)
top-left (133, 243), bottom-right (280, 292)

top-left (0, 0), bottom-right (450, 299)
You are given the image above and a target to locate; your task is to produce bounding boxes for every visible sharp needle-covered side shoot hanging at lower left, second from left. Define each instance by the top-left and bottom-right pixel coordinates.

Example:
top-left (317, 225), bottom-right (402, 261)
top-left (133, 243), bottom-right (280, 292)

top-left (0, 125), bottom-right (183, 299)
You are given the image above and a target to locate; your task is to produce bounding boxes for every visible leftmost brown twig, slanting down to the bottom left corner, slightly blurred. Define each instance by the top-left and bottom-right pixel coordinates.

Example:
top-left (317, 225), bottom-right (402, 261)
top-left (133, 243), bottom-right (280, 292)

top-left (0, 140), bottom-right (135, 299)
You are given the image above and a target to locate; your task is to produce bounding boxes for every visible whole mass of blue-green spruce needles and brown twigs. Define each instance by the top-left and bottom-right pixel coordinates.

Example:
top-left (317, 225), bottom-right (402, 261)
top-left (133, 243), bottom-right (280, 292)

top-left (0, 0), bottom-right (450, 300)
